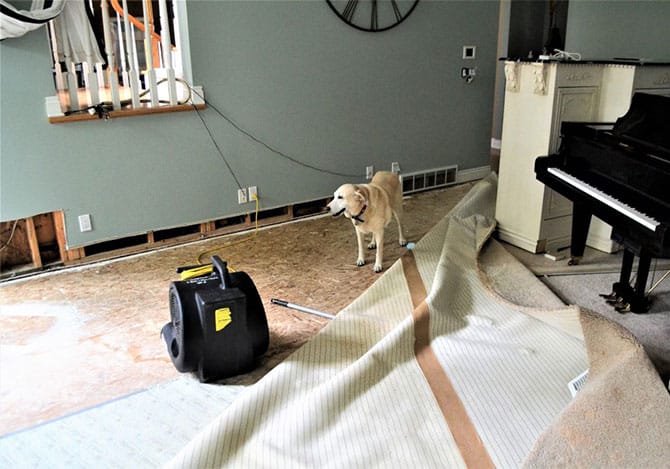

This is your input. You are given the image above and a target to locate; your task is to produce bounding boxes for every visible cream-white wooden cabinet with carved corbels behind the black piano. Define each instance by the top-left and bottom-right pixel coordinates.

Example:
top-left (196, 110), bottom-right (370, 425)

top-left (496, 61), bottom-right (670, 253)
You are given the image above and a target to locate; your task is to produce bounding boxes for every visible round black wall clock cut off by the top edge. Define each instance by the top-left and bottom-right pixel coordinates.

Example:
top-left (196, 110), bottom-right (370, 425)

top-left (326, 0), bottom-right (419, 33)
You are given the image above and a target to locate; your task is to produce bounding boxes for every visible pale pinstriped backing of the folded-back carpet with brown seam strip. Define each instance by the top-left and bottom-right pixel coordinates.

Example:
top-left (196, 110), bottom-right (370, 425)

top-left (171, 175), bottom-right (588, 468)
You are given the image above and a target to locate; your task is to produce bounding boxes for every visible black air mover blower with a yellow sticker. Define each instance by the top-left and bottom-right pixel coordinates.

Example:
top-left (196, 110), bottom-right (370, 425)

top-left (161, 256), bottom-right (269, 381)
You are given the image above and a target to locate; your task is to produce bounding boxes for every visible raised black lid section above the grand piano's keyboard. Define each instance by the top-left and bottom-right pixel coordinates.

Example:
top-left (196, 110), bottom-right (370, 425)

top-left (612, 93), bottom-right (670, 159)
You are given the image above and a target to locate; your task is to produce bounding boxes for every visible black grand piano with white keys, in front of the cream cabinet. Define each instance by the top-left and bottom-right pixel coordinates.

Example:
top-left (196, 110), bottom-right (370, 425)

top-left (535, 93), bottom-right (670, 313)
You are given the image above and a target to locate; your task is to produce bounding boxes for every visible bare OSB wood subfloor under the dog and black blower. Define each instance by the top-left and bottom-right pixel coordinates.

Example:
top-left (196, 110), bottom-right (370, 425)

top-left (0, 183), bottom-right (473, 435)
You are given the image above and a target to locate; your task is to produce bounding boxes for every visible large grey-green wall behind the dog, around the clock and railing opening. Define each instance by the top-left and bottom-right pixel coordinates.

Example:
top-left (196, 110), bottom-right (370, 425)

top-left (0, 0), bottom-right (498, 247)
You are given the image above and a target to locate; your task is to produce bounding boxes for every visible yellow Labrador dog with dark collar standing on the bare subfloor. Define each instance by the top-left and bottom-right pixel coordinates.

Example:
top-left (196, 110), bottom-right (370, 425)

top-left (328, 171), bottom-right (407, 272)
